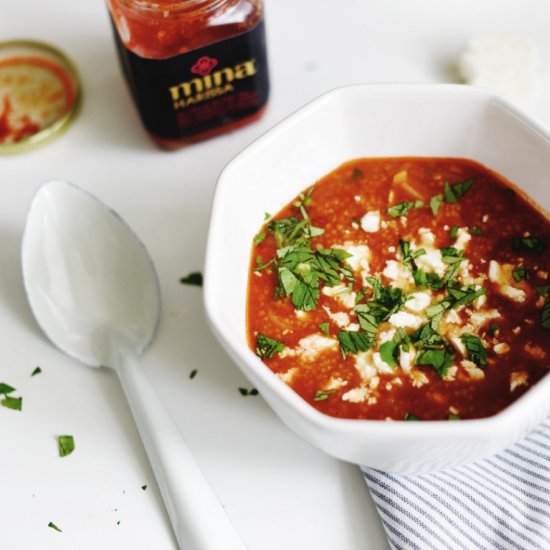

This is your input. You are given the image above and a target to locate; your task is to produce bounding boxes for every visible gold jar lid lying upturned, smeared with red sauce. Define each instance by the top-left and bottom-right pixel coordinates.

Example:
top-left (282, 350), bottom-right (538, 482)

top-left (0, 40), bottom-right (82, 155)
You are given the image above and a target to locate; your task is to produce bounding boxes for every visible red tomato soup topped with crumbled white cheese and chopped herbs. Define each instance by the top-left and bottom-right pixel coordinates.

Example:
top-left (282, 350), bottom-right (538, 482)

top-left (247, 158), bottom-right (550, 420)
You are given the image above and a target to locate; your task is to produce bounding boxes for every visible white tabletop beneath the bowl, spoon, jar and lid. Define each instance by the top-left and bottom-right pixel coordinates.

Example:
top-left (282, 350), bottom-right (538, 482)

top-left (0, 0), bottom-right (550, 550)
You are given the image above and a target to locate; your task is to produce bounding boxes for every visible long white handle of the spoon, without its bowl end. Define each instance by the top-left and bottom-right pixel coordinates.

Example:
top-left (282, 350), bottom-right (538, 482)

top-left (111, 342), bottom-right (246, 550)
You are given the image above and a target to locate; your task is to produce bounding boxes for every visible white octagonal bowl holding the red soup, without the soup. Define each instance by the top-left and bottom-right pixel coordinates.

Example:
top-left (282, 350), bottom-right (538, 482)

top-left (204, 84), bottom-right (550, 473)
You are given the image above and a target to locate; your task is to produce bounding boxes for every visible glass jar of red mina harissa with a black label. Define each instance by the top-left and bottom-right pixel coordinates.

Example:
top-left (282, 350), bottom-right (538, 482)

top-left (107, 0), bottom-right (269, 149)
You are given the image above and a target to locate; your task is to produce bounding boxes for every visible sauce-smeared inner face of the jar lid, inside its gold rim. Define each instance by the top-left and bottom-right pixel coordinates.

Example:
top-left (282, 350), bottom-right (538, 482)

top-left (0, 56), bottom-right (76, 144)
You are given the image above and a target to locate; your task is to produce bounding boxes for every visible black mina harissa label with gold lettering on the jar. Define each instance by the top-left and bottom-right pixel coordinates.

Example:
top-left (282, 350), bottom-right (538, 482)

top-left (111, 20), bottom-right (269, 140)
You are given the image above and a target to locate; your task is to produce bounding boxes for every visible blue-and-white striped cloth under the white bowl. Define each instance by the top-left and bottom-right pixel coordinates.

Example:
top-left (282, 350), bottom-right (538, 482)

top-left (363, 418), bottom-right (550, 550)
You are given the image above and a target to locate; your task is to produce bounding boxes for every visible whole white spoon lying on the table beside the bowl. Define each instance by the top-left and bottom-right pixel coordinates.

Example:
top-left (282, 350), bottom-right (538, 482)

top-left (22, 181), bottom-right (245, 550)
